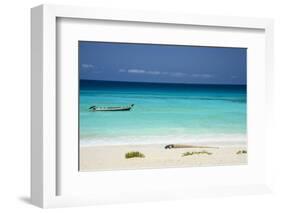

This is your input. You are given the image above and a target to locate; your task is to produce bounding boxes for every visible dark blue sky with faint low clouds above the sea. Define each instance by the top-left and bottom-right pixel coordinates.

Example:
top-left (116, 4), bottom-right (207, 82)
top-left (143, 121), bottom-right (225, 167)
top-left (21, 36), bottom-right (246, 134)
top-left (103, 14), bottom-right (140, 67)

top-left (79, 41), bottom-right (247, 84)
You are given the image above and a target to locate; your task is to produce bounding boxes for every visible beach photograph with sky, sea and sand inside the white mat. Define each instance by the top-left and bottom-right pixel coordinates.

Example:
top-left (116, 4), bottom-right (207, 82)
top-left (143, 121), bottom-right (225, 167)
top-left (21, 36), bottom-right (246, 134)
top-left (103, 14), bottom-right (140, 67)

top-left (78, 41), bottom-right (245, 172)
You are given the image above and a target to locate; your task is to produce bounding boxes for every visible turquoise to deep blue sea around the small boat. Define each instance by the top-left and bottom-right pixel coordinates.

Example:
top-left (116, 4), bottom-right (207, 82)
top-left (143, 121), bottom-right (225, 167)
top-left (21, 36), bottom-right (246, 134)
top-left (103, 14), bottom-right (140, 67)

top-left (79, 80), bottom-right (247, 146)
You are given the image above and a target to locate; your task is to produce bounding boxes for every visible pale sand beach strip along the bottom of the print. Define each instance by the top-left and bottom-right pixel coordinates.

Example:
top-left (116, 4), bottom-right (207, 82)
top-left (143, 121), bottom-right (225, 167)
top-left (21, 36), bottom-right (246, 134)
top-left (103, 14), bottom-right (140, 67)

top-left (80, 145), bottom-right (247, 172)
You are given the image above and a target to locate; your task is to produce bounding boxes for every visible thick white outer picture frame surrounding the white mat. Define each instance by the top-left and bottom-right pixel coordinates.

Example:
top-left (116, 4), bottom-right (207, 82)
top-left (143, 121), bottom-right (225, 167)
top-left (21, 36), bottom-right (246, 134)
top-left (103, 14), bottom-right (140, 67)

top-left (31, 5), bottom-right (273, 208)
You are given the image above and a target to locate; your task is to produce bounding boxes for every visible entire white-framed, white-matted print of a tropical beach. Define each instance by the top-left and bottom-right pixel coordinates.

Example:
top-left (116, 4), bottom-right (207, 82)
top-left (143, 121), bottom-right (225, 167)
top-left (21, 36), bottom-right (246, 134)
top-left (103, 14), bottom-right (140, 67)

top-left (31, 5), bottom-right (273, 207)
